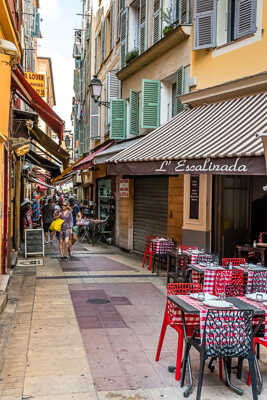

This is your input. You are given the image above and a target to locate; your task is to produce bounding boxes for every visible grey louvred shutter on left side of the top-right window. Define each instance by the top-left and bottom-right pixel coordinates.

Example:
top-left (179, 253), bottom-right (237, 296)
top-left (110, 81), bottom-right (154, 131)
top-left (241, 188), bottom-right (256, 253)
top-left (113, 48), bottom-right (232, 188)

top-left (194, 0), bottom-right (217, 50)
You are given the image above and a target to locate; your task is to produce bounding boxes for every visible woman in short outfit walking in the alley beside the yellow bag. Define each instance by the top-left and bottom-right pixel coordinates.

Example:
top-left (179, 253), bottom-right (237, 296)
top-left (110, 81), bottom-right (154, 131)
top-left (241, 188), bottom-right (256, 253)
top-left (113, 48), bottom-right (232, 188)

top-left (56, 200), bottom-right (73, 259)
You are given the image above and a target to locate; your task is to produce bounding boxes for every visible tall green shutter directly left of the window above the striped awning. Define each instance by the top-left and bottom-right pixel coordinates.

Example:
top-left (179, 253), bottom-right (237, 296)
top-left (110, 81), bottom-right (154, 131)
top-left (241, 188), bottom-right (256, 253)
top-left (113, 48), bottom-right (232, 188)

top-left (141, 79), bottom-right (160, 129)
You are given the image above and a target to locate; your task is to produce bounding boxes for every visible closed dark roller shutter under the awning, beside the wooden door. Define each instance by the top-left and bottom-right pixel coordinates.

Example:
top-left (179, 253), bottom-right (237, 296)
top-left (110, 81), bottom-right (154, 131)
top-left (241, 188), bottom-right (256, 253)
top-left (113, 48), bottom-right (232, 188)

top-left (133, 176), bottom-right (168, 252)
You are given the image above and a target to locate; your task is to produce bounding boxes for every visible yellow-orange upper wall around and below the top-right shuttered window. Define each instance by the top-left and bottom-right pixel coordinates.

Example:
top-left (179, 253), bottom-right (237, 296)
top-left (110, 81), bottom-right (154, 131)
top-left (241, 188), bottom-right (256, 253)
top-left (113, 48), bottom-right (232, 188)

top-left (191, 0), bottom-right (267, 90)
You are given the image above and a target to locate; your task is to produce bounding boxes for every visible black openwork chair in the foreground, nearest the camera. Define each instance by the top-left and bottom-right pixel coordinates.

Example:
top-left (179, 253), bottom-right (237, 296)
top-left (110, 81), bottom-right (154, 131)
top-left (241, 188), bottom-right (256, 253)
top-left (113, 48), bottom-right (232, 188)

top-left (181, 310), bottom-right (258, 400)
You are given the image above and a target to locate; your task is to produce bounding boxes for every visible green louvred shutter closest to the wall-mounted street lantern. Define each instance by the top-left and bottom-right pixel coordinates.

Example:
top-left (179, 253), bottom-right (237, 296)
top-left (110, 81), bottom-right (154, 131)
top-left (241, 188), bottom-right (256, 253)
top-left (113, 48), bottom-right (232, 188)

top-left (110, 99), bottom-right (126, 140)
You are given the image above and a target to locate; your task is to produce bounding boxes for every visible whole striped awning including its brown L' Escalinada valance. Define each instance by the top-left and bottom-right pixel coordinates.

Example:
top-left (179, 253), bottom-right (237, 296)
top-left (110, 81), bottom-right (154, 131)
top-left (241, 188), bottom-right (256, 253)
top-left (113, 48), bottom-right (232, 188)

top-left (108, 93), bottom-right (267, 175)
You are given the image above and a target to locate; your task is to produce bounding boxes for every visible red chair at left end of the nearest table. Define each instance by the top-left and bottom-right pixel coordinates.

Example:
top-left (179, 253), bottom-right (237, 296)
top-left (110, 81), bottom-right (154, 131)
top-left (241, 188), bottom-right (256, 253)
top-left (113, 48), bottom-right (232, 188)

top-left (156, 283), bottom-right (203, 381)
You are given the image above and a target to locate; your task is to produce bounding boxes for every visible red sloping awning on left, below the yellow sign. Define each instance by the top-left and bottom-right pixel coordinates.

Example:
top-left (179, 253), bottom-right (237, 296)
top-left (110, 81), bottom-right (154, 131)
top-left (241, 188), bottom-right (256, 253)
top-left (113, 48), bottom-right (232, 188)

top-left (12, 68), bottom-right (64, 141)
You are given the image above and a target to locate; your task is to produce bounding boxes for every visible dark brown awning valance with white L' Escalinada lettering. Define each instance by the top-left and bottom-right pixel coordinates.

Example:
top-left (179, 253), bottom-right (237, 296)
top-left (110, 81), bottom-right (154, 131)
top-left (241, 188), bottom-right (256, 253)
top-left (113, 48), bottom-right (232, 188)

top-left (108, 156), bottom-right (266, 175)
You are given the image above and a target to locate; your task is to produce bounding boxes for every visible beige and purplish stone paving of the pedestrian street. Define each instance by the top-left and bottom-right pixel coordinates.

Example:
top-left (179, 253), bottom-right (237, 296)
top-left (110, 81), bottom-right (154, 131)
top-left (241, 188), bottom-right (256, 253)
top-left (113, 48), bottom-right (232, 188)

top-left (0, 242), bottom-right (267, 400)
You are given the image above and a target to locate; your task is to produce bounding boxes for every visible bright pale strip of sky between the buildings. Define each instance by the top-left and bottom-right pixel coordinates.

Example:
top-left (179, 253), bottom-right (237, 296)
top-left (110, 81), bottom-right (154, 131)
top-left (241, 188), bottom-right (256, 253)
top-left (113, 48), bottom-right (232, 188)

top-left (38, 0), bottom-right (82, 129)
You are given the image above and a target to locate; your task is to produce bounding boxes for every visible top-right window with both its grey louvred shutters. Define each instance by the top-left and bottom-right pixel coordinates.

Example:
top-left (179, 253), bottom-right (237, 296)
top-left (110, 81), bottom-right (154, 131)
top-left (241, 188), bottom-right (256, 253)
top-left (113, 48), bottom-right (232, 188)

top-left (194, 0), bottom-right (257, 50)
